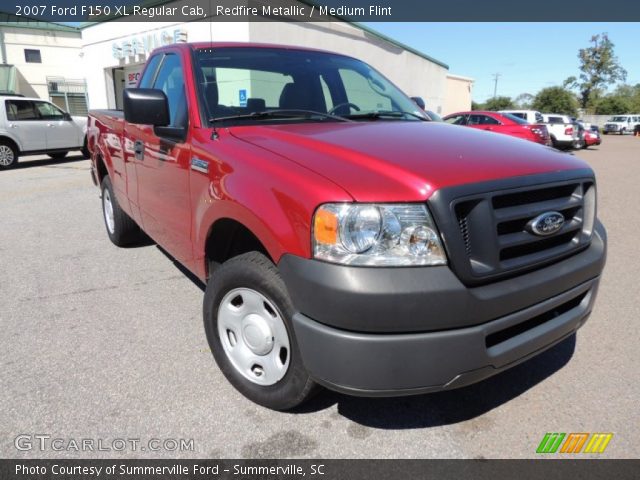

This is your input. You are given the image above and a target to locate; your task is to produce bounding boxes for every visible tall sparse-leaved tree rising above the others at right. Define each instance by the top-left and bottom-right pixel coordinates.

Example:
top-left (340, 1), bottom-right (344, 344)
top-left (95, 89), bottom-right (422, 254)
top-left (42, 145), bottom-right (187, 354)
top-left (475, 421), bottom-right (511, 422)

top-left (564, 33), bottom-right (627, 108)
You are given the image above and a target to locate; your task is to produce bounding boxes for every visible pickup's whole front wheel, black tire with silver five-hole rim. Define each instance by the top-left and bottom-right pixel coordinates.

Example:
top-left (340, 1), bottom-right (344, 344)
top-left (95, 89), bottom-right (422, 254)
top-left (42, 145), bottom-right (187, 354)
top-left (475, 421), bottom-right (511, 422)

top-left (203, 252), bottom-right (316, 410)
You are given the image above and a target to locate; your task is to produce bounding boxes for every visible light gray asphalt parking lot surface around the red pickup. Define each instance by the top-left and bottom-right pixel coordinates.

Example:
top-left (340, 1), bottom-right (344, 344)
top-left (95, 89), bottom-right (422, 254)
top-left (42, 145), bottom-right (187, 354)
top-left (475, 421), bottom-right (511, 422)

top-left (0, 136), bottom-right (640, 458)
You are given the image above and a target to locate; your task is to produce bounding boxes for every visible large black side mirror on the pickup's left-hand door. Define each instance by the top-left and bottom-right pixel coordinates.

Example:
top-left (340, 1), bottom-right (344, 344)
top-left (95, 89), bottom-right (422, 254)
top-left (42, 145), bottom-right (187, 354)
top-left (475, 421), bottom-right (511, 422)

top-left (123, 88), bottom-right (171, 127)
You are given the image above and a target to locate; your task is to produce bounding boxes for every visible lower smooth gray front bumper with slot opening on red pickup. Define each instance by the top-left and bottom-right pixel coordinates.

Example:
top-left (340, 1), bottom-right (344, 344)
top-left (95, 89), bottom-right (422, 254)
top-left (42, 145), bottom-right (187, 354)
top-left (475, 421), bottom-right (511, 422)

top-left (293, 278), bottom-right (599, 396)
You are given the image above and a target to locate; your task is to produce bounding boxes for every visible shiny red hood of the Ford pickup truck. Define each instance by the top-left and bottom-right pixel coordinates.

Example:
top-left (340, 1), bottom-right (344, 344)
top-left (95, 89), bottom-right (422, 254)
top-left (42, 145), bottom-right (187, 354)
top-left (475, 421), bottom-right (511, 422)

top-left (230, 121), bottom-right (588, 202)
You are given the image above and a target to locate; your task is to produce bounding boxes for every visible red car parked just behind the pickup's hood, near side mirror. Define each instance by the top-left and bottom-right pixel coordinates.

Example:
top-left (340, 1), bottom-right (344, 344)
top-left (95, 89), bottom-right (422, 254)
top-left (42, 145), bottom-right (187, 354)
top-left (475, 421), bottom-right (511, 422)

top-left (444, 110), bottom-right (551, 145)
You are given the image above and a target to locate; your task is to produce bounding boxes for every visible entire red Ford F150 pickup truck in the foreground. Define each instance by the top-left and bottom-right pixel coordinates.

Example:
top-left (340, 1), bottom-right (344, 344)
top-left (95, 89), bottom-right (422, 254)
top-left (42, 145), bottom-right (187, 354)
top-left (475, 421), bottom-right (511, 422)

top-left (88, 43), bottom-right (606, 409)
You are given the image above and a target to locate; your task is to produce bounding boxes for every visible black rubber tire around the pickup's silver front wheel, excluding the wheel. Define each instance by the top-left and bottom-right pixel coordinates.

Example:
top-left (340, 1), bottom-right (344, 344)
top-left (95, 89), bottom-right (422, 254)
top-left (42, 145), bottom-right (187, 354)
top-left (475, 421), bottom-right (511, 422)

top-left (203, 252), bottom-right (318, 410)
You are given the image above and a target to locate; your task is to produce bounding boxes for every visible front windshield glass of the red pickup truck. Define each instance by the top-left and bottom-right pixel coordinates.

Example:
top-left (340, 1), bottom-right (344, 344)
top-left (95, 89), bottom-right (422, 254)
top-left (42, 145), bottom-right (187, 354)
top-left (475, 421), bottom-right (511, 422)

top-left (195, 47), bottom-right (429, 124)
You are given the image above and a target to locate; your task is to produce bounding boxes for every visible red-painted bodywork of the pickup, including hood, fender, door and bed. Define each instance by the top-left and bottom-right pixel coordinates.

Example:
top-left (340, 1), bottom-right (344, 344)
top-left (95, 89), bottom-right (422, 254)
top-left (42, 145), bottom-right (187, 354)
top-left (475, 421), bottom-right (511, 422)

top-left (88, 43), bottom-right (588, 279)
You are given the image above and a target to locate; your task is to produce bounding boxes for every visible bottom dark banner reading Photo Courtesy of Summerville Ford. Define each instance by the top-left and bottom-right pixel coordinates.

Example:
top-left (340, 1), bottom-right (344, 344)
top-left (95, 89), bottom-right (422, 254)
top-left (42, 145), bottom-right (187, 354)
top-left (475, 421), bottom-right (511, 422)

top-left (0, 459), bottom-right (640, 480)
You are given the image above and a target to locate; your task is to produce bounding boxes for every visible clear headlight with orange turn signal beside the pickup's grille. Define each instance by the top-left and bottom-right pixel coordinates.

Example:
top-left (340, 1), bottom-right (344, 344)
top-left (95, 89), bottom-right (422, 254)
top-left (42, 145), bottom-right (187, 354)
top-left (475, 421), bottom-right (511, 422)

top-left (313, 203), bottom-right (447, 267)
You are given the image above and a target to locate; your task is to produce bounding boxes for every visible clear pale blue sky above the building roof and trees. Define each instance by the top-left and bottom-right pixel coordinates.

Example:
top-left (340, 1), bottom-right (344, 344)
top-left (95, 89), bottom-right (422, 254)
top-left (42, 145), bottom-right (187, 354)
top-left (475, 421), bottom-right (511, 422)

top-left (366, 22), bottom-right (640, 102)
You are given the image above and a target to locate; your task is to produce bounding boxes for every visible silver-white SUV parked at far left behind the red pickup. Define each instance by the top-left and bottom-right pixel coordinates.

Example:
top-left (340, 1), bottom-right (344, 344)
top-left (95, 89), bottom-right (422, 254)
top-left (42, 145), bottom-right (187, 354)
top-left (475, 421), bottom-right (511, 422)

top-left (0, 95), bottom-right (88, 169)
